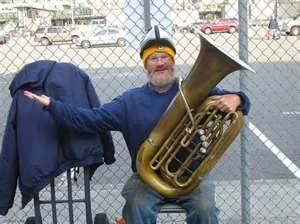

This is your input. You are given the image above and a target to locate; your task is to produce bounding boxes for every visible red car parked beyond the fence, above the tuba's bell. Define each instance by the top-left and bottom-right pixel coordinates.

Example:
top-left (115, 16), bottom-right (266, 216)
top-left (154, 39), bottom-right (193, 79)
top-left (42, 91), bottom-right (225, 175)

top-left (200, 18), bottom-right (240, 34)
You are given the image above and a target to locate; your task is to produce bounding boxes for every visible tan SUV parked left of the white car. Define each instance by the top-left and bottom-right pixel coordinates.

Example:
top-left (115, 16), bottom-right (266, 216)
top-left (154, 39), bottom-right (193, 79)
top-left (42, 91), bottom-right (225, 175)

top-left (33, 26), bottom-right (79, 46)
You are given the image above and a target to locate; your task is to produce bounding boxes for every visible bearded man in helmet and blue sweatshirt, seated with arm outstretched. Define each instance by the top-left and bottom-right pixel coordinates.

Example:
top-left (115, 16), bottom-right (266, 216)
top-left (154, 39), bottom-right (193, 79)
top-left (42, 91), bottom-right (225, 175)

top-left (24, 26), bottom-right (250, 224)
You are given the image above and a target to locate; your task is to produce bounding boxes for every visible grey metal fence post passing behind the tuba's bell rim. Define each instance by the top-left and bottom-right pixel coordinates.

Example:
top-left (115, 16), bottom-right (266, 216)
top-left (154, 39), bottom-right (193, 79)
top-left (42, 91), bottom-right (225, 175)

top-left (238, 0), bottom-right (250, 224)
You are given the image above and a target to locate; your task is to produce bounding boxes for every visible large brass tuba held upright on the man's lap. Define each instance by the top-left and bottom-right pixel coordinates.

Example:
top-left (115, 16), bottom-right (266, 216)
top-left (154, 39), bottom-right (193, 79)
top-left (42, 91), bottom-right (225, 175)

top-left (136, 32), bottom-right (254, 198)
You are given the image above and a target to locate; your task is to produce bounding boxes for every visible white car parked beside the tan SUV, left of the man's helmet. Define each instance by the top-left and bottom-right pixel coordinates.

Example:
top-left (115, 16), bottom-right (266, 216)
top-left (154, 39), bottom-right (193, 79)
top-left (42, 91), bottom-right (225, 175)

top-left (77, 27), bottom-right (127, 48)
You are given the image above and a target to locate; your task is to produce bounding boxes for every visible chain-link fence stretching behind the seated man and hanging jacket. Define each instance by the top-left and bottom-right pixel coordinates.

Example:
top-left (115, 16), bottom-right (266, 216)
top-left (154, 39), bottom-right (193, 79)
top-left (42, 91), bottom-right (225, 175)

top-left (0, 0), bottom-right (300, 224)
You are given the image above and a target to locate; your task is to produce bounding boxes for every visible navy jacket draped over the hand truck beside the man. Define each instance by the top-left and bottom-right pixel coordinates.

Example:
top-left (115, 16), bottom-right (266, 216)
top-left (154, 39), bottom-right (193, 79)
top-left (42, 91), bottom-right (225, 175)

top-left (0, 60), bottom-right (115, 215)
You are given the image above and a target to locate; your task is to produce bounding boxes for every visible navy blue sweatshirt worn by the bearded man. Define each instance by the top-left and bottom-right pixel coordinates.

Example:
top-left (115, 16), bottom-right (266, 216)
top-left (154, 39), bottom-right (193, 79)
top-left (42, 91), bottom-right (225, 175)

top-left (48, 82), bottom-right (250, 172)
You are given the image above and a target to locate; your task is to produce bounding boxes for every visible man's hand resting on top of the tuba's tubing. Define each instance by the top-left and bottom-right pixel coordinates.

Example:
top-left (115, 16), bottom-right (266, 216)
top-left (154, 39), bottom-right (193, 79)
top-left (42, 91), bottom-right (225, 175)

top-left (212, 94), bottom-right (241, 112)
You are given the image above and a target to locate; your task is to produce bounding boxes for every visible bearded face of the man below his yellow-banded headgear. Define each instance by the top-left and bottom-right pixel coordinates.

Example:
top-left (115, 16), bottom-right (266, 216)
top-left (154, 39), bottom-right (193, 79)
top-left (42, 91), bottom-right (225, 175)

top-left (145, 52), bottom-right (174, 88)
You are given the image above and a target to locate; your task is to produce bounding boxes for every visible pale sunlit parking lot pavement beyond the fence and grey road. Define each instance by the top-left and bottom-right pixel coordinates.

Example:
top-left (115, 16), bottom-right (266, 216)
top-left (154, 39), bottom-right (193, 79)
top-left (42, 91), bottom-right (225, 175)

top-left (0, 27), bottom-right (300, 74)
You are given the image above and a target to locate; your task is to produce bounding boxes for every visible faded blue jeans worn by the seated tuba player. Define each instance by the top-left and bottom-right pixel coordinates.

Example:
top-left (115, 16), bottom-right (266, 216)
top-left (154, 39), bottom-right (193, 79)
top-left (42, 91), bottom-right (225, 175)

top-left (122, 174), bottom-right (219, 224)
